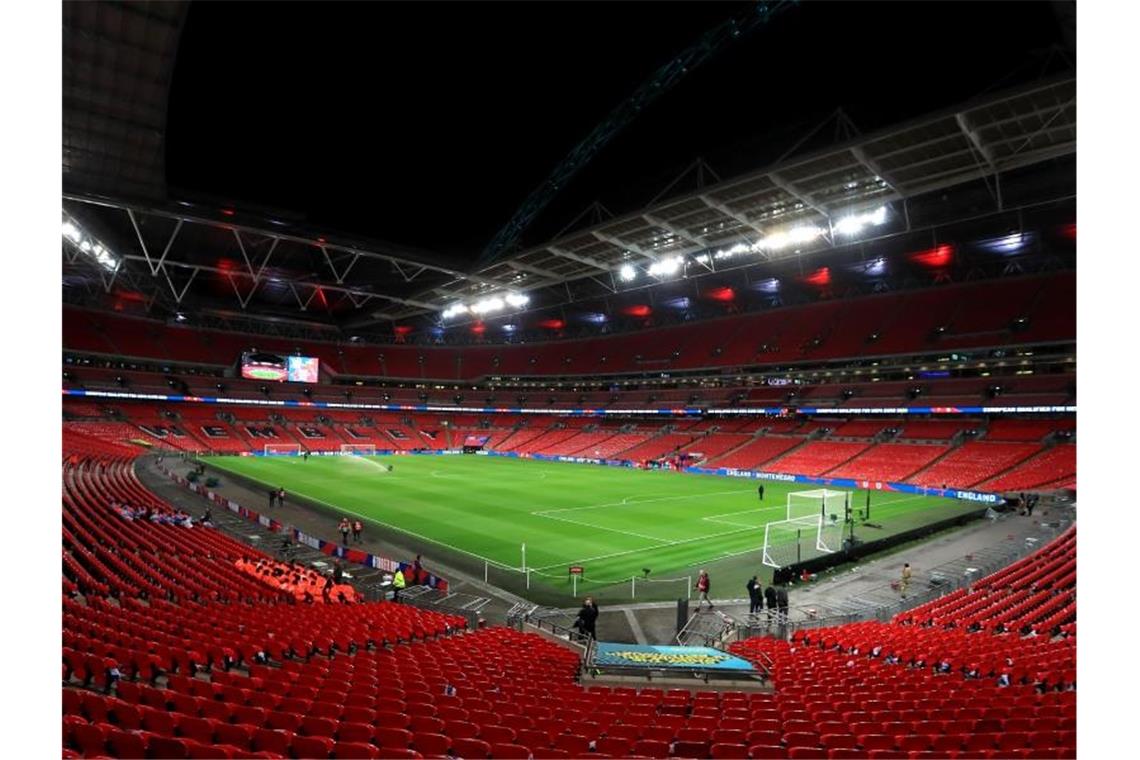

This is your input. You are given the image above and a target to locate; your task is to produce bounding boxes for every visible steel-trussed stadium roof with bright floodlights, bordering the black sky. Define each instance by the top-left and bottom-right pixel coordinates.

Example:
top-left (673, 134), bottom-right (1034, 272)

top-left (64, 74), bottom-right (1076, 329)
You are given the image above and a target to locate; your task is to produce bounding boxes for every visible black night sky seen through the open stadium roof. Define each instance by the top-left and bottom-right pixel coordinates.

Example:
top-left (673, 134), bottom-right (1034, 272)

top-left (166, 1), bottom-right (1065, 259)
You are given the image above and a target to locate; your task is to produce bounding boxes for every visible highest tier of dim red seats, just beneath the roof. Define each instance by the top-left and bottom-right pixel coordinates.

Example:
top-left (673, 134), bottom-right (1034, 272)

top-left (64, 272), bottom-right (1076, 381)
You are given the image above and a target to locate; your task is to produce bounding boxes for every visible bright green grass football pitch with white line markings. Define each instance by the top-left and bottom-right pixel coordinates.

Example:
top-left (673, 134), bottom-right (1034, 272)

top-left (204, 456), bottom-right (979, 598)
